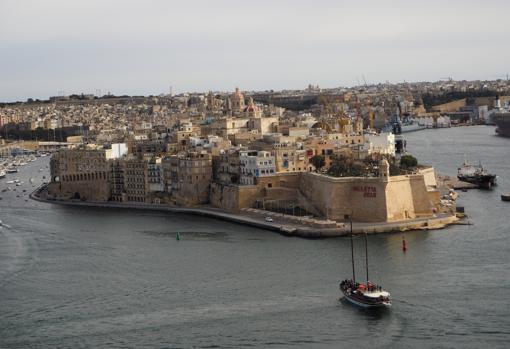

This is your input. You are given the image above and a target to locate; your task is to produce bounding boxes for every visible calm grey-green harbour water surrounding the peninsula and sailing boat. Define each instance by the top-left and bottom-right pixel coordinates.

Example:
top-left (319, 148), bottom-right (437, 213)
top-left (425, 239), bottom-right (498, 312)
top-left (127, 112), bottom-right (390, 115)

top-left (0, 126), bottom-right (510, 348)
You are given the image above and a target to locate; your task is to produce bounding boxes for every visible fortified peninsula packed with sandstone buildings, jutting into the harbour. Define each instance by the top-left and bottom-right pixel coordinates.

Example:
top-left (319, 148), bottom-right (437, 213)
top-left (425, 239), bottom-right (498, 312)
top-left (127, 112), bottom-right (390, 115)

top-left (20, 89), bottom-right (457, 237)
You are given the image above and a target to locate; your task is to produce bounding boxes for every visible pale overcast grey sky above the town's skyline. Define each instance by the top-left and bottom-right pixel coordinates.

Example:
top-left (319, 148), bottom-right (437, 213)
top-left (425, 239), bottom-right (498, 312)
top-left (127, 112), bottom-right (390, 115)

top-left (0, 0), bottom-right (510, 101)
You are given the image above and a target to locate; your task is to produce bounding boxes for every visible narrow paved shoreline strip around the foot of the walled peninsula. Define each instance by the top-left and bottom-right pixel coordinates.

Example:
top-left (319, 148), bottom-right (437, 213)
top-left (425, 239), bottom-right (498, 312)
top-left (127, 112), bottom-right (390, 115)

top-left (29, 184), bottom-right (459, 239)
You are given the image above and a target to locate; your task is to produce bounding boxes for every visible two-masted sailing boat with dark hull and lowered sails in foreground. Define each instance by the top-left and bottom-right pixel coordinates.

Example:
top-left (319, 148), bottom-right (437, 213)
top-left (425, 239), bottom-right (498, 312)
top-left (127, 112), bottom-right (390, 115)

top-left (340, 216), bottom-right (391, 308)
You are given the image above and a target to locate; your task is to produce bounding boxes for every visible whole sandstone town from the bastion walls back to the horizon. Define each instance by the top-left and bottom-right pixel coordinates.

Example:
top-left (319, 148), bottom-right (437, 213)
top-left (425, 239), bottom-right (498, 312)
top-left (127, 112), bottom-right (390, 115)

top-left (0, 80), bottom-right (508, 227)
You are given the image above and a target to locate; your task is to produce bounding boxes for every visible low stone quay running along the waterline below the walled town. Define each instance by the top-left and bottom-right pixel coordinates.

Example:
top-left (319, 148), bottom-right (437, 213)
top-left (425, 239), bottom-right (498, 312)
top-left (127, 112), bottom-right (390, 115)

top-left (30, 185), bottom-right (459, 238)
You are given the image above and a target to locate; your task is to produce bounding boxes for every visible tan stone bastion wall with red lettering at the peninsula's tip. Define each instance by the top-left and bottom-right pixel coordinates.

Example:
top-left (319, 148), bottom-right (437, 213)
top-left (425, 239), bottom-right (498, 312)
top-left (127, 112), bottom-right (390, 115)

top-left (211, 169), bottom-right (437, 222)
